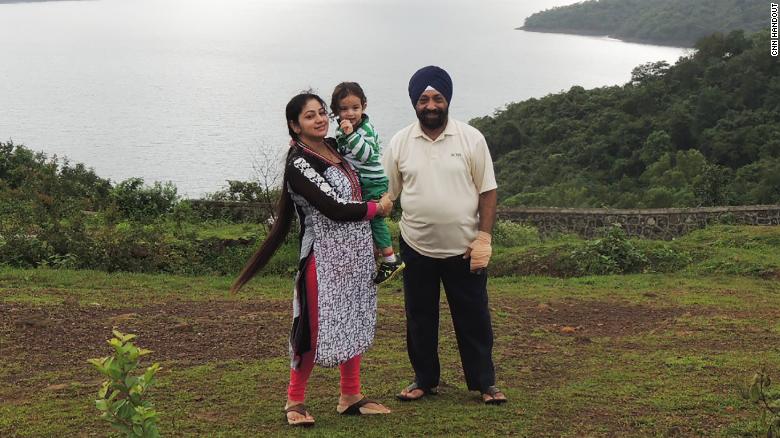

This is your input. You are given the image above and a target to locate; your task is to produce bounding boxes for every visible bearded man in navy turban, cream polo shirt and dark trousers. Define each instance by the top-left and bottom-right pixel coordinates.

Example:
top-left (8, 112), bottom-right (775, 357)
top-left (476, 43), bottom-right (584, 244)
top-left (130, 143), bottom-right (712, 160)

top-left (382, 66), bottom-right (506, 404)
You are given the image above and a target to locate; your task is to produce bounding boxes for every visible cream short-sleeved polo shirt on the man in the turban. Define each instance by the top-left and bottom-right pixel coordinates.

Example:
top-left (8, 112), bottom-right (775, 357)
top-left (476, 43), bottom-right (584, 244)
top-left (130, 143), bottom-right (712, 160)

top-left (382, 118), bottom-right (496, 258)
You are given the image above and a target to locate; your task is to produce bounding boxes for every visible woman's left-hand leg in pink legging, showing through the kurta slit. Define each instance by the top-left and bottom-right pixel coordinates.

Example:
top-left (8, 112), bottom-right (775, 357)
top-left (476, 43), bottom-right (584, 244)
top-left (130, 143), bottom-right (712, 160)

top-left (287, 254), bottom-right (319, 402)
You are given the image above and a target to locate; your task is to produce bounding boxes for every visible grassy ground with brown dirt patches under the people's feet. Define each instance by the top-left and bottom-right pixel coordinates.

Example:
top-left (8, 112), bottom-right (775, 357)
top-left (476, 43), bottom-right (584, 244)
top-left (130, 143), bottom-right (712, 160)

top-left (0, 228), bottom-right (780, 437)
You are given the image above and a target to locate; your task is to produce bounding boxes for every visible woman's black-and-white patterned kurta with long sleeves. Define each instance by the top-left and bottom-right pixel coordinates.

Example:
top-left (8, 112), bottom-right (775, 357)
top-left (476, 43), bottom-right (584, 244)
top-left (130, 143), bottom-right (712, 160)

top-left (287, 145), bottom-right (377, 368)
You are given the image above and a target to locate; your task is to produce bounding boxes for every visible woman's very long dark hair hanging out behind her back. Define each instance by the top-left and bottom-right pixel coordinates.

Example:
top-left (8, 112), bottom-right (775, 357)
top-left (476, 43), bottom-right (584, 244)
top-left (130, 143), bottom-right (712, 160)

top-left (230, 90), bottom-right (325, 293)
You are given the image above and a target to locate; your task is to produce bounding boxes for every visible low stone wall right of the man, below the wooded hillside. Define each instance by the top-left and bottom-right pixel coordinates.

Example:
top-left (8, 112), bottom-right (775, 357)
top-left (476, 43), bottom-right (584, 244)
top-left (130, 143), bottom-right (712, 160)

top-left (498, 205), bottom-right (780, 240)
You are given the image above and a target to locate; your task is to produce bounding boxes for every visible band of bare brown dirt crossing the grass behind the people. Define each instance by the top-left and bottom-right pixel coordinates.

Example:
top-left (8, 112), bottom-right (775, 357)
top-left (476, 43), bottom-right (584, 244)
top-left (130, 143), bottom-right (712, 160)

top-left (0, 300), bottom-right (690, 378)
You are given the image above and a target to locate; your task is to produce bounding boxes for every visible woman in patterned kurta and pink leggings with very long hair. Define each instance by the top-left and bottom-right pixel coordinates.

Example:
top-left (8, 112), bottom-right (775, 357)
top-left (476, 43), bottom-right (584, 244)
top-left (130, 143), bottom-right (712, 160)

top-left (231, 93), bottom-right (392, 425)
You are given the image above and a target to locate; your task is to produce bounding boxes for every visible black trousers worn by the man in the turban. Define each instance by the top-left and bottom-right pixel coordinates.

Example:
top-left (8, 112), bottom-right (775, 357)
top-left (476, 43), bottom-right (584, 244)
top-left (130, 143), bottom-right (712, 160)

top-left (400, 239), bottom-right (496, 392)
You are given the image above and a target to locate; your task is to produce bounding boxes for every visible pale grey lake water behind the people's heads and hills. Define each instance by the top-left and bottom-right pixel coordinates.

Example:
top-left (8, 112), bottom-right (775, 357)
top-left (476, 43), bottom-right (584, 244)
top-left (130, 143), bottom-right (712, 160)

top-left (0, 0), bottom-right (687, 197)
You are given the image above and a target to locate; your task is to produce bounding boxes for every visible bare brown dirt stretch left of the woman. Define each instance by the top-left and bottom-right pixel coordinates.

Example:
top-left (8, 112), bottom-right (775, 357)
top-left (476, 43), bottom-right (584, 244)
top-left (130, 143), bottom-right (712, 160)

top-left (0, 301), bottom-right (289, 371)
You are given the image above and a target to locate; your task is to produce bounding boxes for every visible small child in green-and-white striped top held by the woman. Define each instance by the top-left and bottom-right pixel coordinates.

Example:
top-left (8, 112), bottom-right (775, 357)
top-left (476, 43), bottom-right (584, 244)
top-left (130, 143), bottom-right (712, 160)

top-left (330, 82), bottom-right (404, 284)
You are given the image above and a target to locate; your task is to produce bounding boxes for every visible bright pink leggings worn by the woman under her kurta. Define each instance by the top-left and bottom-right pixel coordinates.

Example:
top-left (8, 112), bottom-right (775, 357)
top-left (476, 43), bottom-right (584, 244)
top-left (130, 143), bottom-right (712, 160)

top-left (287, 254), bottom-right (360, 401)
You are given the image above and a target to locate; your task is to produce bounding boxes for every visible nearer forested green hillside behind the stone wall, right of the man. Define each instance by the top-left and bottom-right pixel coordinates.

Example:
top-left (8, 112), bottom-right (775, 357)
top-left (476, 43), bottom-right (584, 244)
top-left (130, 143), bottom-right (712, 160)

top-left (471, 31), bottom-right (780, 208)
